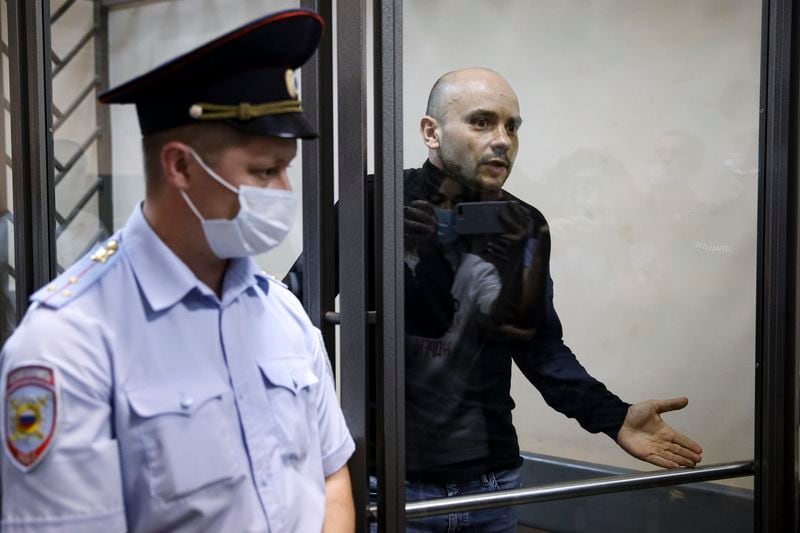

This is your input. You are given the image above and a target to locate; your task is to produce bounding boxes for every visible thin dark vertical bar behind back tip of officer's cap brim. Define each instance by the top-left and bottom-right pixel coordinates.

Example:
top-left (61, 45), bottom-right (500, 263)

top-left (94, 2), bottom-right (114, 236)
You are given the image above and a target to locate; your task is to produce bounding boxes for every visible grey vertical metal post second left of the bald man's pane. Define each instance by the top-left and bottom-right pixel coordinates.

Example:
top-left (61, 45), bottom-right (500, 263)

top-left (336, 0), bottom-right (368, 531)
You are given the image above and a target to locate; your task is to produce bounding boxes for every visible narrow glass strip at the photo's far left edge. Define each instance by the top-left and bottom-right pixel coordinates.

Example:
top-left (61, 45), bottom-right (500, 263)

top-left (0, 0), bottom-right (17, 343)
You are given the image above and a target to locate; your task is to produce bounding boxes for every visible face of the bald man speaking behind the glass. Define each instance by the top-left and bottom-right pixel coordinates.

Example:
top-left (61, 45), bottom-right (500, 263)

top-left (439, 73), bottom-right (522, 195)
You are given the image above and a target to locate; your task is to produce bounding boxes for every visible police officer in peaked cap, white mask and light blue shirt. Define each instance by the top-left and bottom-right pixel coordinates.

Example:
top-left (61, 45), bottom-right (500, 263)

top-left (1, 10), bottom-right (354, 532)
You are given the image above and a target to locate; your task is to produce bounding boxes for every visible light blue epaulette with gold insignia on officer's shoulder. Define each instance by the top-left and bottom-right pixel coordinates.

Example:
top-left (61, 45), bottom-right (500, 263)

top-left (31, 234), bottom-right (120, 309)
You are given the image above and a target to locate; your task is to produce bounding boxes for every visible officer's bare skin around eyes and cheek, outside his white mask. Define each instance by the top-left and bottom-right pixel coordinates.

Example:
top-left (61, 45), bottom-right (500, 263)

top-left (191, 136), bottom-right (297, 219)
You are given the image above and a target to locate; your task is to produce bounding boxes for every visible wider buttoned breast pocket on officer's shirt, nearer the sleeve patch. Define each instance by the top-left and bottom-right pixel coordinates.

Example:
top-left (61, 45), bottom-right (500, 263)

top-left (127, 374), bottom-right (238, 500)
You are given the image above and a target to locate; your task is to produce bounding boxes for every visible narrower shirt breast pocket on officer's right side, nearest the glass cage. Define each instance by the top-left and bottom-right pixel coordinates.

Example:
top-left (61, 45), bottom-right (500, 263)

top-left (258, 357), bottom-right (319, 461)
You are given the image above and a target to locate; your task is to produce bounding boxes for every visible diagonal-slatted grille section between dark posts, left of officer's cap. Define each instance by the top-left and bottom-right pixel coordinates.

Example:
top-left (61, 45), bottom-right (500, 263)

top-left (50, 0), bottom-right (113, 272)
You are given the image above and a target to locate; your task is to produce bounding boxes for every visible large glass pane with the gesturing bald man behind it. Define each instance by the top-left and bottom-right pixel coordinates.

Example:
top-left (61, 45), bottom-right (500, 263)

top-left (403, 0), bottom-right (761, 531)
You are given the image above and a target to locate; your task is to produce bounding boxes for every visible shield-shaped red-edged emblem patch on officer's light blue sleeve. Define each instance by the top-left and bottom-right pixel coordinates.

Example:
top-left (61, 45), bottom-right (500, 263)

top-left (3, 365), bottom-right (59, 472)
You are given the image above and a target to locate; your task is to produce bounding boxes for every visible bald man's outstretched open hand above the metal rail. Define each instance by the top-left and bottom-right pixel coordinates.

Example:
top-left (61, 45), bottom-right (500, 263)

top-left (617, 398), bottom-right (703, 468)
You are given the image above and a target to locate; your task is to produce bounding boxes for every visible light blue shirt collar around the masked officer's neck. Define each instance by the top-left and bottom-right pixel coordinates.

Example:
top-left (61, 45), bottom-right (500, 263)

top-left (122, 205), bottom-right (260, 311)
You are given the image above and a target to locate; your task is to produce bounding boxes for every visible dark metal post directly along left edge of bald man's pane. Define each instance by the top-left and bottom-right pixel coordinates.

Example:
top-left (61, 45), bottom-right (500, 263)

top-left (373, 0), bottom-right (405, 533)
